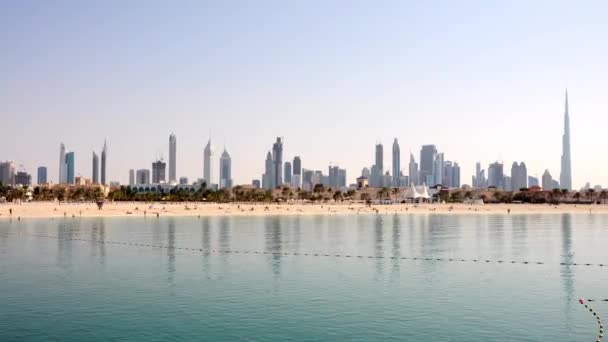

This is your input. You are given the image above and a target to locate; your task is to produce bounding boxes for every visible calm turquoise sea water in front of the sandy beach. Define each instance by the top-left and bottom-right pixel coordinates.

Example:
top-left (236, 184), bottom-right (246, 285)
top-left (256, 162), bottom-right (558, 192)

top-left (0, 214), bottom-right (608, 341)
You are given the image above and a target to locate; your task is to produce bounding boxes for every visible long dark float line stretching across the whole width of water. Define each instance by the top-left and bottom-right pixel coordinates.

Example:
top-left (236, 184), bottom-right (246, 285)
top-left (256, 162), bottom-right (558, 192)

top-left (0, 232), bottom-right (608, 268)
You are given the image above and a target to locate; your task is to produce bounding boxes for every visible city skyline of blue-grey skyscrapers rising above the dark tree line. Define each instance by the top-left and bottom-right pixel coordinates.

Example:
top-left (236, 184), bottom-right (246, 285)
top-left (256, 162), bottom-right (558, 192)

top-left (2, 93), bottom-right (591, 191)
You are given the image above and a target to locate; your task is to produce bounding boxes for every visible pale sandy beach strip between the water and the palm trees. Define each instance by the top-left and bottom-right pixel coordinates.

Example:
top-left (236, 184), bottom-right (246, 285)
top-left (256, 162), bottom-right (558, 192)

top-left (0, 202), bottom-right (608, 219)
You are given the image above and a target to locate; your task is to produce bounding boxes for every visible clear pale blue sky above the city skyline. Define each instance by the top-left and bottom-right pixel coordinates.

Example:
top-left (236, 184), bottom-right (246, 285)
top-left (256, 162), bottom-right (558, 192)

top-left (0, 1), bottom-right (608, 187)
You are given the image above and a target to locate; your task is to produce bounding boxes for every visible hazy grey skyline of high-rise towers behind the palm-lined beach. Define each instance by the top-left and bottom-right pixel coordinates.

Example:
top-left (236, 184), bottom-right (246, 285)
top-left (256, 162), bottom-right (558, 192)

top-left (0, 90), bottom-right (572, 191)
